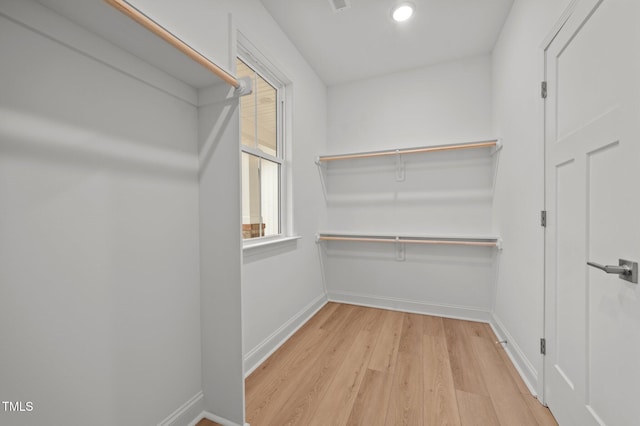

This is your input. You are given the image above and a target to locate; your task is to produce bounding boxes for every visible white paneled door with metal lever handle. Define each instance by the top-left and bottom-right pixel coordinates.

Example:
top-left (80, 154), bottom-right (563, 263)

top-left (544, 0), bottom-right (640, 426)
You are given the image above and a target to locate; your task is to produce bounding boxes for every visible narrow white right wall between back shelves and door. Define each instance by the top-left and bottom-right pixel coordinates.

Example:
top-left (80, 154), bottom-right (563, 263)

top-left (493, 0), bottom-right (569, 391)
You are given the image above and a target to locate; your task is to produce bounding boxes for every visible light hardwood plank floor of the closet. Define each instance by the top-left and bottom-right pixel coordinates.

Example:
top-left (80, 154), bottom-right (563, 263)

top-left (245, 303), bottom-right (557, 426)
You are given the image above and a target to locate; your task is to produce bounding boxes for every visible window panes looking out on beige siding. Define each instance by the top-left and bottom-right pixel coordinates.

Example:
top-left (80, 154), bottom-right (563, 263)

top-left (236, 58), bottom-right (285, 240)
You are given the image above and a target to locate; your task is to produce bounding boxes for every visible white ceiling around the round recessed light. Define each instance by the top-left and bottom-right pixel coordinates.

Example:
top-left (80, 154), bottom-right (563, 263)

top-left (261, 0), bottom-right (513, 85)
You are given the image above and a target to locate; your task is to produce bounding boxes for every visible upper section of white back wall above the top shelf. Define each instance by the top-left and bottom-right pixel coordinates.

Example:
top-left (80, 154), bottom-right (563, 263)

top-left (327, 56), bottom-right (494, 153)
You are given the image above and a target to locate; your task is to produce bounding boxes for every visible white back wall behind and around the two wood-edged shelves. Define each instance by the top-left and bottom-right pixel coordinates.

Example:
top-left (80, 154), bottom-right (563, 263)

top-left (320, 56), bottom-right (499, 319)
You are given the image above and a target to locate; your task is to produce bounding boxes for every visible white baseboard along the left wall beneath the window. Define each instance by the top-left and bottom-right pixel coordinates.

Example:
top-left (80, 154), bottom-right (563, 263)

top-left (244, 293), bottom-right (327, 377)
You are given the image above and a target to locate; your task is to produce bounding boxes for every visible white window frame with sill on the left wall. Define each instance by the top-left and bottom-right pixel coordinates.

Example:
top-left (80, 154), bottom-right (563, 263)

top-left (234, 36), bottom-right (299, 249)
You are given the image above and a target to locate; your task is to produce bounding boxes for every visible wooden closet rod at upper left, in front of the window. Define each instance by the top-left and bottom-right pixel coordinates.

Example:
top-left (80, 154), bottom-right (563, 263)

top-left (104, 0), bottom-right (240, 89)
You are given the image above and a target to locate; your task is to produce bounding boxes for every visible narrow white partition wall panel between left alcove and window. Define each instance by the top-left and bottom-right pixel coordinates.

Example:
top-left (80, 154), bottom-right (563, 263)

top-left (198, 91), bottom-right (244, 425)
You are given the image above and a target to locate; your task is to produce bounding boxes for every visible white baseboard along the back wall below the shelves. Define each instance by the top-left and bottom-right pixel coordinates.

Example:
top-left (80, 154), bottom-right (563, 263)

top-left (328, 291), bottom-right (491, 323)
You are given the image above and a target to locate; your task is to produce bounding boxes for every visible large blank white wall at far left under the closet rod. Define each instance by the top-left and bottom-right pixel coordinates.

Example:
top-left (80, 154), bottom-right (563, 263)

top-left (0, 1), bottom-right (201, 426)
